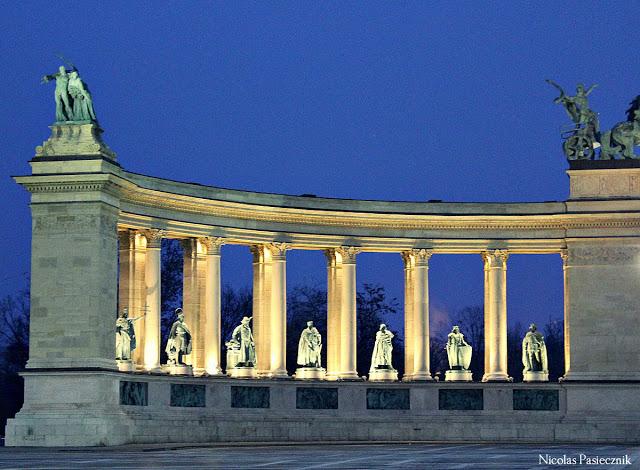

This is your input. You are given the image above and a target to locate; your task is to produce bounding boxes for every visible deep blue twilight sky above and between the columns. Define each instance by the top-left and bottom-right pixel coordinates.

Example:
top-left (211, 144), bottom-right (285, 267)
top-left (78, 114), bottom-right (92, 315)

top-left (0, 1), bottom-right (640, 334)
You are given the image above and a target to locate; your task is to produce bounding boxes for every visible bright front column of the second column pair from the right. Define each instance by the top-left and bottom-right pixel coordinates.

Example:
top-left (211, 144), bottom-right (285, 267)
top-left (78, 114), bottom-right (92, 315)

top-left (411, 250), bottom-right (433, 380)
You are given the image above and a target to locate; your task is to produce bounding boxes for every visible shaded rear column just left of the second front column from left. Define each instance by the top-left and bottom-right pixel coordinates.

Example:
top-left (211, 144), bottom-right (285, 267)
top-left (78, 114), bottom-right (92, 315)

top-left (182, 238), bottom-right (207, 375)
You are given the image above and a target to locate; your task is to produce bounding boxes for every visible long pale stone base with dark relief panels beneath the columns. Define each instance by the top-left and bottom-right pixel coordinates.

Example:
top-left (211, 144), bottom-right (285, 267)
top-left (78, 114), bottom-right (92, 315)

top-left (5, 370), bottom-right (640, 447)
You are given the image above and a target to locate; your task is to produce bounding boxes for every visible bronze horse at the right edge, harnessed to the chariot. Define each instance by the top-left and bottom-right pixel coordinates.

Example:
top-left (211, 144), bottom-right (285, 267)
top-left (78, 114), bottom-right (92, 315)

top-left (600, 95), bottom-right (640, 160)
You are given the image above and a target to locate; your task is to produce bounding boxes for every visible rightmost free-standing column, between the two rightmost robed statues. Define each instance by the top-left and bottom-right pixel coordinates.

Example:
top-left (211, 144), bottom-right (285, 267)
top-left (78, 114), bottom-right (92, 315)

top-left (482, 250), bottom-right (510, 382)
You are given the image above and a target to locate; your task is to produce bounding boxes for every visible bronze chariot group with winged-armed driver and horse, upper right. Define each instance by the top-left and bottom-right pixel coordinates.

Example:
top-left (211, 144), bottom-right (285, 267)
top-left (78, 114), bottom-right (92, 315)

top-left (547, 80), bottom-right (640, 160)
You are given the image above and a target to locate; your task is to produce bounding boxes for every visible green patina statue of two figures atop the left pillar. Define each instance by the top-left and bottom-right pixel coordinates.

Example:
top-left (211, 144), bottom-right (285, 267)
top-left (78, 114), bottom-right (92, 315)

top-left (42, 65), bottom-right (97, 122)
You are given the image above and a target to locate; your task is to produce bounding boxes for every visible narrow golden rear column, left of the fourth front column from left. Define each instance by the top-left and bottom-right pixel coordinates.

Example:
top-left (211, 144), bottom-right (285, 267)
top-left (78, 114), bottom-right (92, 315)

top-left (325, 248), bottom-right (342, 380)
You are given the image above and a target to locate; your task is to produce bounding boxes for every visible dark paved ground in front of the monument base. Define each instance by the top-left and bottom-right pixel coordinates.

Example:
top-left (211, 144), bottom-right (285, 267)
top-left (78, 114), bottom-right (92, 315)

top-left (0, 444), bottom-right (640, 470)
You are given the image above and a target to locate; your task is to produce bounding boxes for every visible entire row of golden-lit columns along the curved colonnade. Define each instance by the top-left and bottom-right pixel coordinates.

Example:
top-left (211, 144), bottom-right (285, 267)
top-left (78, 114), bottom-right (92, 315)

top-left (119, 229), bottom-right (564, 381)
